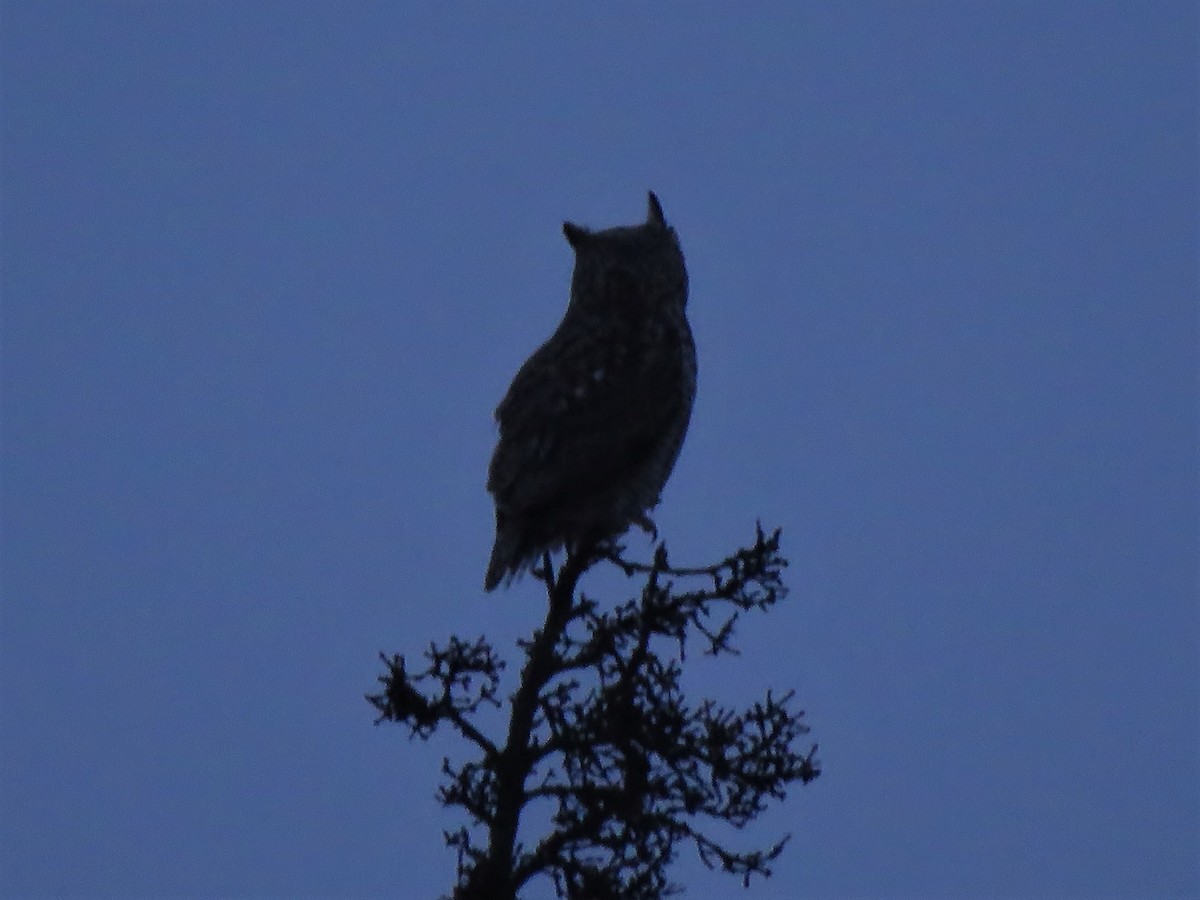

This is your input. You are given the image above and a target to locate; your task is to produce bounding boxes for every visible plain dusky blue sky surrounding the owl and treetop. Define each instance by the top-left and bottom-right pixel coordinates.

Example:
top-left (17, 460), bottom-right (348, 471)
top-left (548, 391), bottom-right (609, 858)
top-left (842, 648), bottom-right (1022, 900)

top-left (0, 0), bottom-right (1200, 898)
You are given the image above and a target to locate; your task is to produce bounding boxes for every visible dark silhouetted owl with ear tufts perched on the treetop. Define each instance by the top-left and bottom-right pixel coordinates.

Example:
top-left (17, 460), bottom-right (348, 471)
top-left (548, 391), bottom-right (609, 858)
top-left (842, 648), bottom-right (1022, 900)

top-left (484, 192), bottom-right (696, 590)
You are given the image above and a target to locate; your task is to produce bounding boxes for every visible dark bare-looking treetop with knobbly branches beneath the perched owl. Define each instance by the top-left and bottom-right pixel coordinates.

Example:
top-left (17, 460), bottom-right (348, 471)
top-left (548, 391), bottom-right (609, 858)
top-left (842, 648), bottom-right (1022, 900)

top-left (367, 526), bottom-right (820, 900)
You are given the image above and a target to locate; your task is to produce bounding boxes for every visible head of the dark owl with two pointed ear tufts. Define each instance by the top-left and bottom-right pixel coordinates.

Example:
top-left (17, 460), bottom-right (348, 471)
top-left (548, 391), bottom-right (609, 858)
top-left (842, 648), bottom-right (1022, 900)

top-left (563, 191), bottom-right (688, 307)
